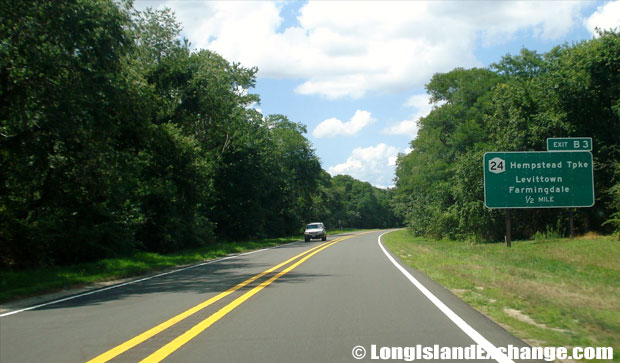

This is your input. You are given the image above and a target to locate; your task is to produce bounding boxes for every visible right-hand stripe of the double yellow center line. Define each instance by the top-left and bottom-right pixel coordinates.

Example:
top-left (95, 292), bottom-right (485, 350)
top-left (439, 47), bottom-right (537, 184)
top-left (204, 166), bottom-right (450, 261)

top-left (140, 236), bottom-right (353, 363)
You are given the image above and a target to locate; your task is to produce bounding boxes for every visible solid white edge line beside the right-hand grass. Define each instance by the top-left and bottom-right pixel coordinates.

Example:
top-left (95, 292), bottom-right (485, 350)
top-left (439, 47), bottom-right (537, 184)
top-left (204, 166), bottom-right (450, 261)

top-left (377, 232), bottom-right (514, 363)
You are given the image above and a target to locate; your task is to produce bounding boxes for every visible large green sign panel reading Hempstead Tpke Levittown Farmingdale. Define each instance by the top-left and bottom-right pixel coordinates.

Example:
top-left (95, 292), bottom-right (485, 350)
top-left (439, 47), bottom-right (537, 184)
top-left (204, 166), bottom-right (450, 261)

top-left (483, 151), bottom-right (594, 208)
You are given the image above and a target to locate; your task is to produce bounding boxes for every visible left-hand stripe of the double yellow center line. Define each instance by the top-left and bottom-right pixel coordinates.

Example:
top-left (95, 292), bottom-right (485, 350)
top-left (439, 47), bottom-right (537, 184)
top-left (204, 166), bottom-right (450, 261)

top-left (86, 240), bottom-right (339, 363)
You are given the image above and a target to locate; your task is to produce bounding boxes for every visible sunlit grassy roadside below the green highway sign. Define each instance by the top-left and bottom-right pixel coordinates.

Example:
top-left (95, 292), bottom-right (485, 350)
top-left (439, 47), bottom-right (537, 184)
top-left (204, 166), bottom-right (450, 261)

top-left (383, 230), bottom-right (620, 360)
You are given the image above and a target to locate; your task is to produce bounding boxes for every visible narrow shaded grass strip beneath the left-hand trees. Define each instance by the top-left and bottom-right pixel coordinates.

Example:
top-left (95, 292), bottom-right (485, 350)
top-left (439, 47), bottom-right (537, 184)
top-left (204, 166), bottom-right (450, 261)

top-left (0, 229), bottom-right (364, 303)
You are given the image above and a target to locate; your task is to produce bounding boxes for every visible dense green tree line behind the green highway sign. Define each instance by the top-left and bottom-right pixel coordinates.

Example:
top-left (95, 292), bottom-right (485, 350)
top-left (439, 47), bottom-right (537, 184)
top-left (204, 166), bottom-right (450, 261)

top-left (395, 31), bottom-right (620, 240)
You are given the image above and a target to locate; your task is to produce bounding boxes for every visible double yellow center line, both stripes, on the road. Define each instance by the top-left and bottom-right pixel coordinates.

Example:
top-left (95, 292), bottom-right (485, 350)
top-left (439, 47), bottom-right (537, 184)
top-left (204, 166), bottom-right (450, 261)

top-left (87, 236), bottom-right (360, 363)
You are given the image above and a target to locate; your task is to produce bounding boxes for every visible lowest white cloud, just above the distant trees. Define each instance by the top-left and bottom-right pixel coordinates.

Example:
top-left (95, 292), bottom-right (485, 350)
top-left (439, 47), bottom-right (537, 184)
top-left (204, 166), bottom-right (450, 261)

top-left (327, 143), bottom-right (399, 187)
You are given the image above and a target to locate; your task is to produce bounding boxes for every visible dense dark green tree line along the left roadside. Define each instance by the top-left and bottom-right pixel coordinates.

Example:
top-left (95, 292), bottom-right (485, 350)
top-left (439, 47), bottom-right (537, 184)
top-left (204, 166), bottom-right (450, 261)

top-left (0, 0), bottom-right (397, 268)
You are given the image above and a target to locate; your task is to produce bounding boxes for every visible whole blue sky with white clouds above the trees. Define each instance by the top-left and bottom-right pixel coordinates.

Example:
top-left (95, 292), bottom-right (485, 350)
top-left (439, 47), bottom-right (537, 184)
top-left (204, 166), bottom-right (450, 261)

top-left (134, 0), bottom-right (620, 188)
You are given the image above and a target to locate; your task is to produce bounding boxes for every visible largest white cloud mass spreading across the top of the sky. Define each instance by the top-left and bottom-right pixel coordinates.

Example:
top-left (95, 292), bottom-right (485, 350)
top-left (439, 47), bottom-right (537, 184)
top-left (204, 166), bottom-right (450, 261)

top-left (140, 1), bottom-right (584, 99)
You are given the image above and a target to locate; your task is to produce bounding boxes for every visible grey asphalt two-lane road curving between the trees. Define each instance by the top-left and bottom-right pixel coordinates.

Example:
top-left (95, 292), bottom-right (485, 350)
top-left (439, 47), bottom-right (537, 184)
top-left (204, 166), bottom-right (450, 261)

top-left (0, 231), bottom-right (536, 363)
